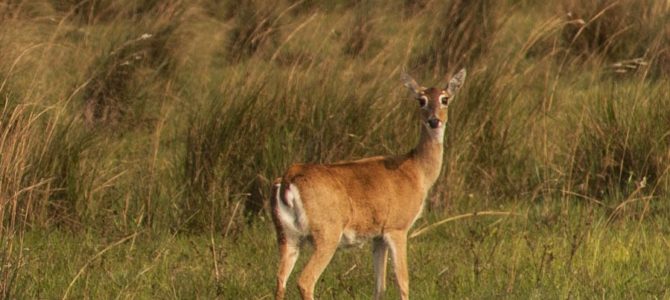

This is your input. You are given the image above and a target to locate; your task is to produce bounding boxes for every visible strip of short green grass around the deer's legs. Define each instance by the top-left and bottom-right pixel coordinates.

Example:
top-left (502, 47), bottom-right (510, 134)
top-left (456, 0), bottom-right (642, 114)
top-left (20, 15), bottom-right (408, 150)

top-left (7, 203), bottom-right (670, 299)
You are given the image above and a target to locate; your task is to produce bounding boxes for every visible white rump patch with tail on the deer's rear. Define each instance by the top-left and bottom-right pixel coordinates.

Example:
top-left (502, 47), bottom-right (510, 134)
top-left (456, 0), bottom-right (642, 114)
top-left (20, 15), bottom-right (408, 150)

top-left (275, 184), bottom-right (308, 236)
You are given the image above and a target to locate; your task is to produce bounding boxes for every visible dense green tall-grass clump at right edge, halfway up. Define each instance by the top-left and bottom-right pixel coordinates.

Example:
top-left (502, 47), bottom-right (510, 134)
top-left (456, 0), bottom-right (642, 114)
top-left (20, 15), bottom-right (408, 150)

top-left (572, 82), bottom-right (670, 197)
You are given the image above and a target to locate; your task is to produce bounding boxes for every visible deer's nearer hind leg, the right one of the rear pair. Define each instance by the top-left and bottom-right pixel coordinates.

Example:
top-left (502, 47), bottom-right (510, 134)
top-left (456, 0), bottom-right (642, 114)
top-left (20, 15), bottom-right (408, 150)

top-left (298, 232), bottom-right (340, 300)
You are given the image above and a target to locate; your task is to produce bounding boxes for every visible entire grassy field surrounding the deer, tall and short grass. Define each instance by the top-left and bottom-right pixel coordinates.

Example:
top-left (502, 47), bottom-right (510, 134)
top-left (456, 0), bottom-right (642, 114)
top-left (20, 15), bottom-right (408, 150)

top-left (0, 0), bottom-right (670, 299)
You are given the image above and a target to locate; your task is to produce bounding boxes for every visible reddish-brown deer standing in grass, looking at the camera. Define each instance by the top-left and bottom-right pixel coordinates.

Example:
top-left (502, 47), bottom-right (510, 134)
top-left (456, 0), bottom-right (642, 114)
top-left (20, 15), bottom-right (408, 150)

top-left (270, 69), bottom-right (466, 299)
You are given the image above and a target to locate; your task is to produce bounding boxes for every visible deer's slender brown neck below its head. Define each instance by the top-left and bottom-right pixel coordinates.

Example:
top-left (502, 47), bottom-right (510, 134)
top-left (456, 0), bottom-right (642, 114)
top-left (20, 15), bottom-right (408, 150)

top-left (410, 126), bottom-right (444, 188)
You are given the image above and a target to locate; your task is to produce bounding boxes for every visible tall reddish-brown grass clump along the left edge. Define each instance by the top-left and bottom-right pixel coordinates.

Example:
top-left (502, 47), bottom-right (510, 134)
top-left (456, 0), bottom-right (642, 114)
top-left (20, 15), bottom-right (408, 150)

top-left (0, 101), bottom-right (92, 298)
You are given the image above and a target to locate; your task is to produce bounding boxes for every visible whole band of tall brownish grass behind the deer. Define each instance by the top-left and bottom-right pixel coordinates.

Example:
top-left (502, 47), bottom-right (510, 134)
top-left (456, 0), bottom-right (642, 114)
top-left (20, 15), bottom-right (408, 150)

top-left (0, 1), bottom-right (669, 232)
